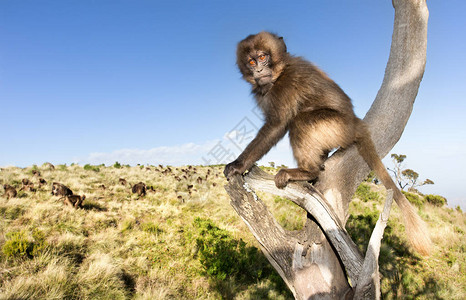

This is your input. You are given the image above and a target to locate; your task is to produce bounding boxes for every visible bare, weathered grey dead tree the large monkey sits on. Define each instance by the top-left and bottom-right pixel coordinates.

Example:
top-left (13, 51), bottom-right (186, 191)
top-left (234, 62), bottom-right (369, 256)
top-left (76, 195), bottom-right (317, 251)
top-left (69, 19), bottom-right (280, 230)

top-left (225, 0), bottom-right (429, 299)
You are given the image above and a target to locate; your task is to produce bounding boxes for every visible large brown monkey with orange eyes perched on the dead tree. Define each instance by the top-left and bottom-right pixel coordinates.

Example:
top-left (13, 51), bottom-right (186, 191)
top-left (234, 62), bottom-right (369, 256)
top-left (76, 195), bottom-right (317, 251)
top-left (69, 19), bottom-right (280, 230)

top-left (224, 32), bottom-right (430, 254)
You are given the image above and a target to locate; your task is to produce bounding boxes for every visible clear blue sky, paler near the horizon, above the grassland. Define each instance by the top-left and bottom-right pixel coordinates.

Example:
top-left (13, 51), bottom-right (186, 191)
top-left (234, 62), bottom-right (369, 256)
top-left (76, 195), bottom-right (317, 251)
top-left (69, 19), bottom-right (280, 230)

top-left (0, 0), bottom-right (466, 208)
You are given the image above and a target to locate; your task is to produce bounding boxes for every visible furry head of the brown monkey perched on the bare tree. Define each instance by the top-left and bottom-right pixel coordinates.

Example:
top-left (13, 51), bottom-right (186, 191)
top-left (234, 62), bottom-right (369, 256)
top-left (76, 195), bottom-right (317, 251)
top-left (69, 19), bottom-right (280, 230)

top-left (236, 32), bottom-right (288, 86)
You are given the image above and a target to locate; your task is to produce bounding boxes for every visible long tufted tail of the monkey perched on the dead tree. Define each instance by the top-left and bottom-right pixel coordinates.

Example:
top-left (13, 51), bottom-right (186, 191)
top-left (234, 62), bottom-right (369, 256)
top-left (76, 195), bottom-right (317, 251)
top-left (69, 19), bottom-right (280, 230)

top-left (356, 120), bottom-right (432, 255)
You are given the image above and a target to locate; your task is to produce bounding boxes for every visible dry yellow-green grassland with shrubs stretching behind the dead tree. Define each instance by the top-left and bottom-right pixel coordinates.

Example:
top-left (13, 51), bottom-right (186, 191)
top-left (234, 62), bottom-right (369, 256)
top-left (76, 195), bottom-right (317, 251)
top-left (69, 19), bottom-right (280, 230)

top-left (0, 164), bottom-right (466, 299)
